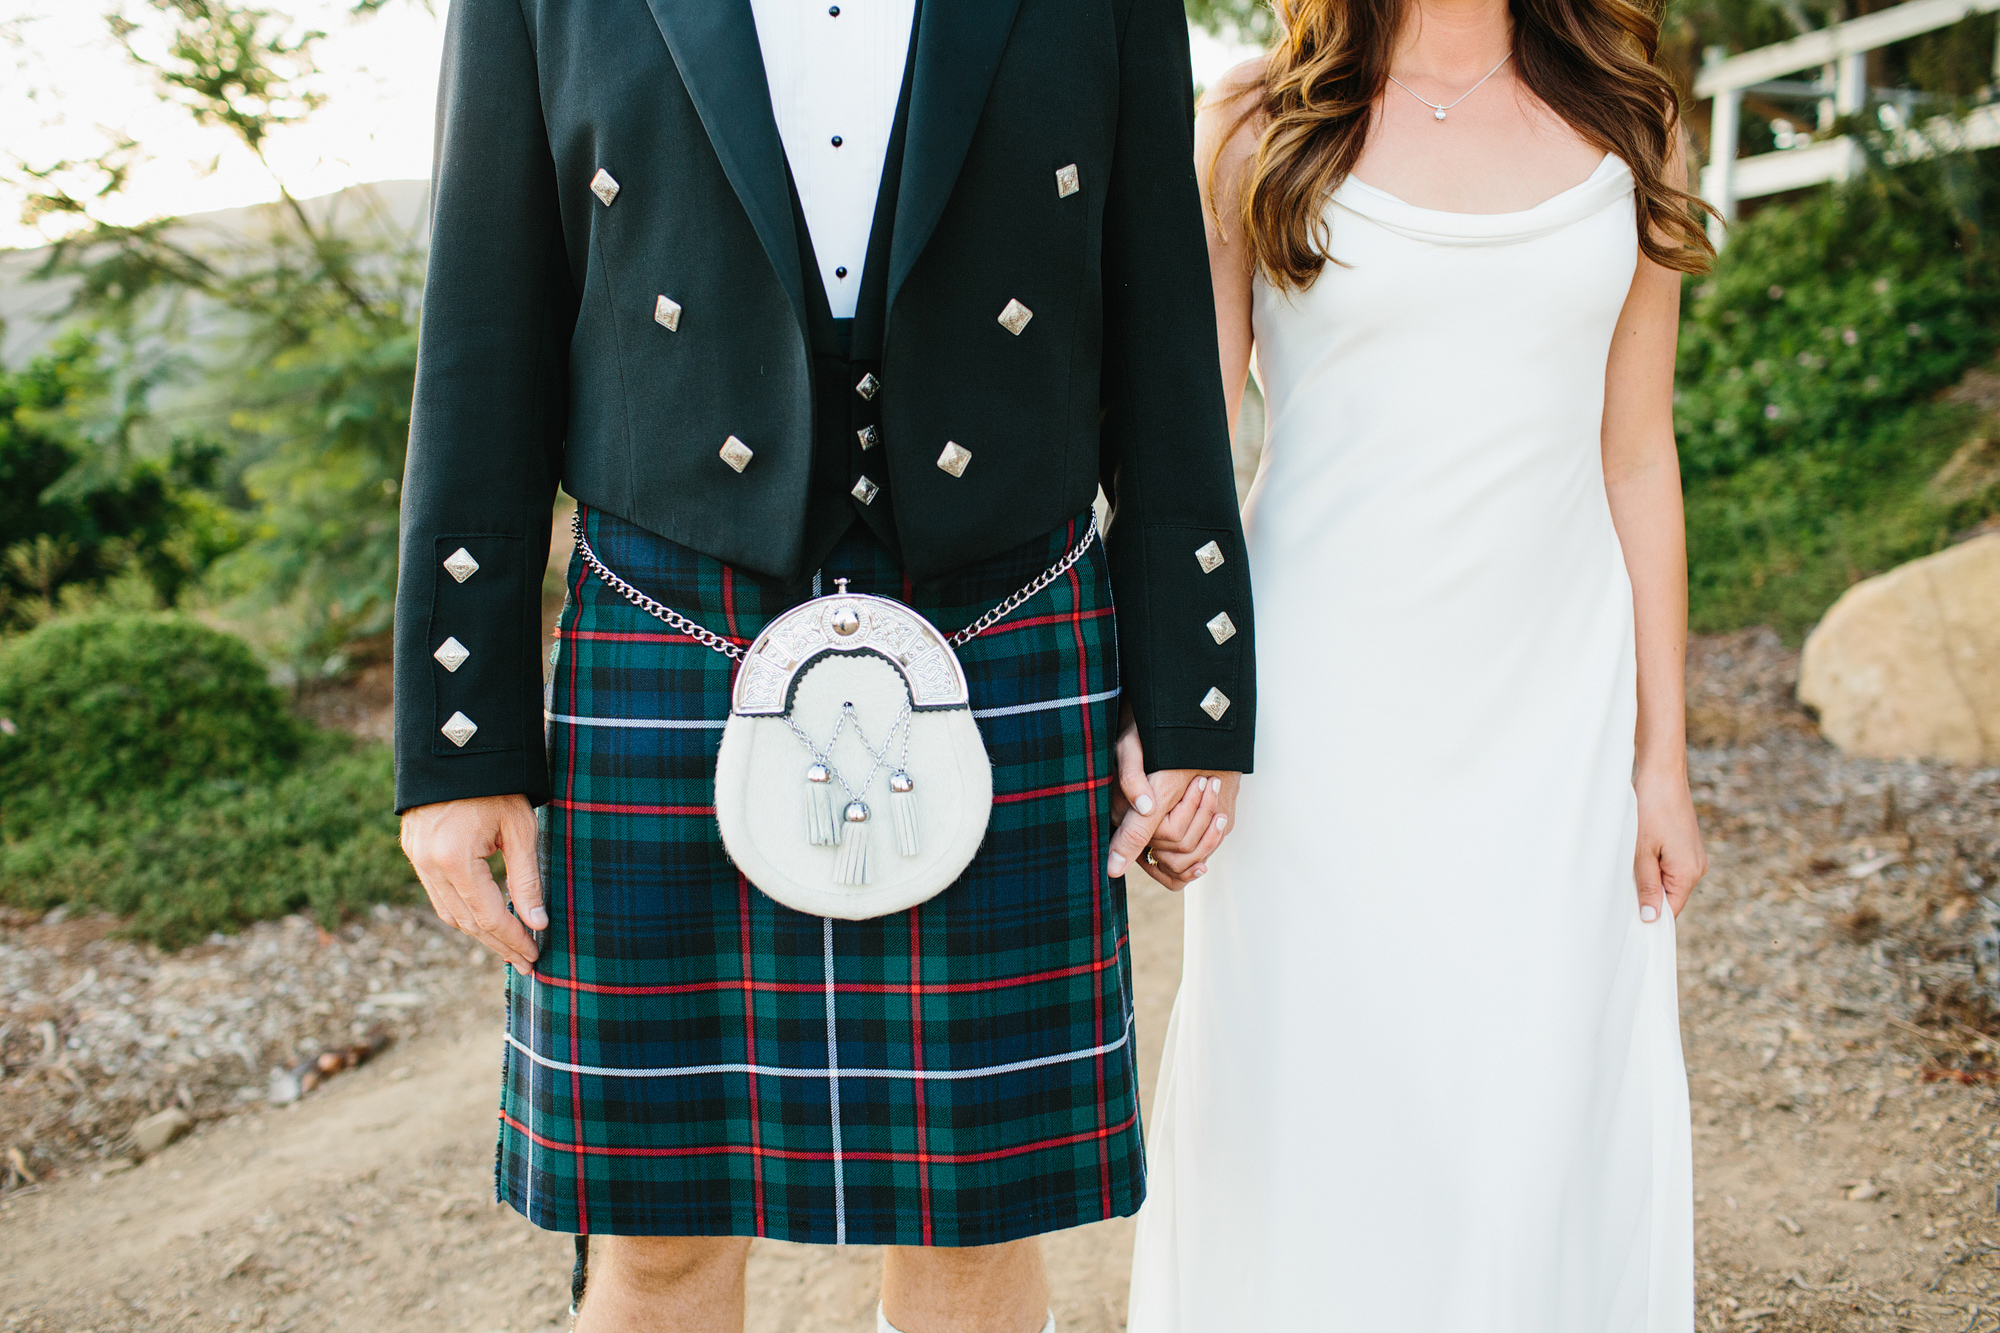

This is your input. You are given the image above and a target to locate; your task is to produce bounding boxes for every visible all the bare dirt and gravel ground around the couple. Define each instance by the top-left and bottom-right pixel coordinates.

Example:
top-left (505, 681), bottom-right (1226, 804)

top-left (0, 632), bottom-right (2000, 1333)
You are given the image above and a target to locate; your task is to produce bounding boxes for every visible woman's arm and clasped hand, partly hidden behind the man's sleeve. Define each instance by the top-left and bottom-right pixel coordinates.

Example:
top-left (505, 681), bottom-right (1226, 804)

top-left (1118, 60), bottom-right (1262, 889)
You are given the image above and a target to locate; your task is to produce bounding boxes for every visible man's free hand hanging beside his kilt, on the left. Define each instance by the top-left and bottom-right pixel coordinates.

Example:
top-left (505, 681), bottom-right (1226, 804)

top-left (402, 797), bottom-right (548, 977)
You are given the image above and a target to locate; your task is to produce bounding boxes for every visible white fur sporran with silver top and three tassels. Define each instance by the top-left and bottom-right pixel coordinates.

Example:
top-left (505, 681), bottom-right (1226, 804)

top-left (716, 578), bottom-right (994, 921)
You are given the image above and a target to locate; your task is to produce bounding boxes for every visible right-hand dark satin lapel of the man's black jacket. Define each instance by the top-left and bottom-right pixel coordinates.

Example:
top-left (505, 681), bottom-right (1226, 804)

top-left (888, 0), bottom-right (1020, 306)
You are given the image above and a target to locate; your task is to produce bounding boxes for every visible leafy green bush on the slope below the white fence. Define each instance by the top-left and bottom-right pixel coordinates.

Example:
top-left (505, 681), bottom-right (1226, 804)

top-left (1674, 154), bottom-right (2000, 638)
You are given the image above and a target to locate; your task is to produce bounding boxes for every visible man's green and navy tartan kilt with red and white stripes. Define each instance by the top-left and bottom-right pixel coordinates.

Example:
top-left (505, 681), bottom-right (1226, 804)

top-left (496, 510), bottom-right (1144, 1245)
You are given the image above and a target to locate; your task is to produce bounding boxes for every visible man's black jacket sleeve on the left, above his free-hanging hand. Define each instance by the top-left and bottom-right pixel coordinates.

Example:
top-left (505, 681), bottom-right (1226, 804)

top-left (396, 0), bottom-right (576, 811)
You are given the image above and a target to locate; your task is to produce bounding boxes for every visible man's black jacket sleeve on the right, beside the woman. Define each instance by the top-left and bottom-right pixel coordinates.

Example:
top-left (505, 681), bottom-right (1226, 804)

top-left (1100, 0), bottom-right (1256, 773)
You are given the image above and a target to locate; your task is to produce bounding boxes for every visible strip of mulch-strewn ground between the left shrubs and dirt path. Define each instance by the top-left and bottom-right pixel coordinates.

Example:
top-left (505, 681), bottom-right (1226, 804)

top-left (0, 907), bottom-right (500, 1187)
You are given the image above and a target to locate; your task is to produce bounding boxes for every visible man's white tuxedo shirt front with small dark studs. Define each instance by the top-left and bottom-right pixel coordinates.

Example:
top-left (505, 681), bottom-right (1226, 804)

top-left (750, 0), bottom-right (916, 320)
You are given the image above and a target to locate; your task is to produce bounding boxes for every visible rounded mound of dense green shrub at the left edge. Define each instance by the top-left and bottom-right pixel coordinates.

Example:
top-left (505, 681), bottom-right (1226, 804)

top-left (0, 614), bottom-right (300, 837)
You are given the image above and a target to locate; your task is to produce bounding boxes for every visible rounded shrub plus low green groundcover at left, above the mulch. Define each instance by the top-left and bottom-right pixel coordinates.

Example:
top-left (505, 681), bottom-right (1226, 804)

top-left (0, 614), bottom-right (412, 947)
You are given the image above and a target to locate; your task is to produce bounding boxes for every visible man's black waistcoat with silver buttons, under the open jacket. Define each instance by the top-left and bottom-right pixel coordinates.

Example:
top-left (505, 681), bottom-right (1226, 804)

top-left (786, 9), bottom-right (924, 568)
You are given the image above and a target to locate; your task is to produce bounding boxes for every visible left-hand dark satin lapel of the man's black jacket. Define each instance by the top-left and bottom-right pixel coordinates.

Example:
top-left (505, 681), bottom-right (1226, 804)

top-left (646, 0), bottom-right (804, 328)
